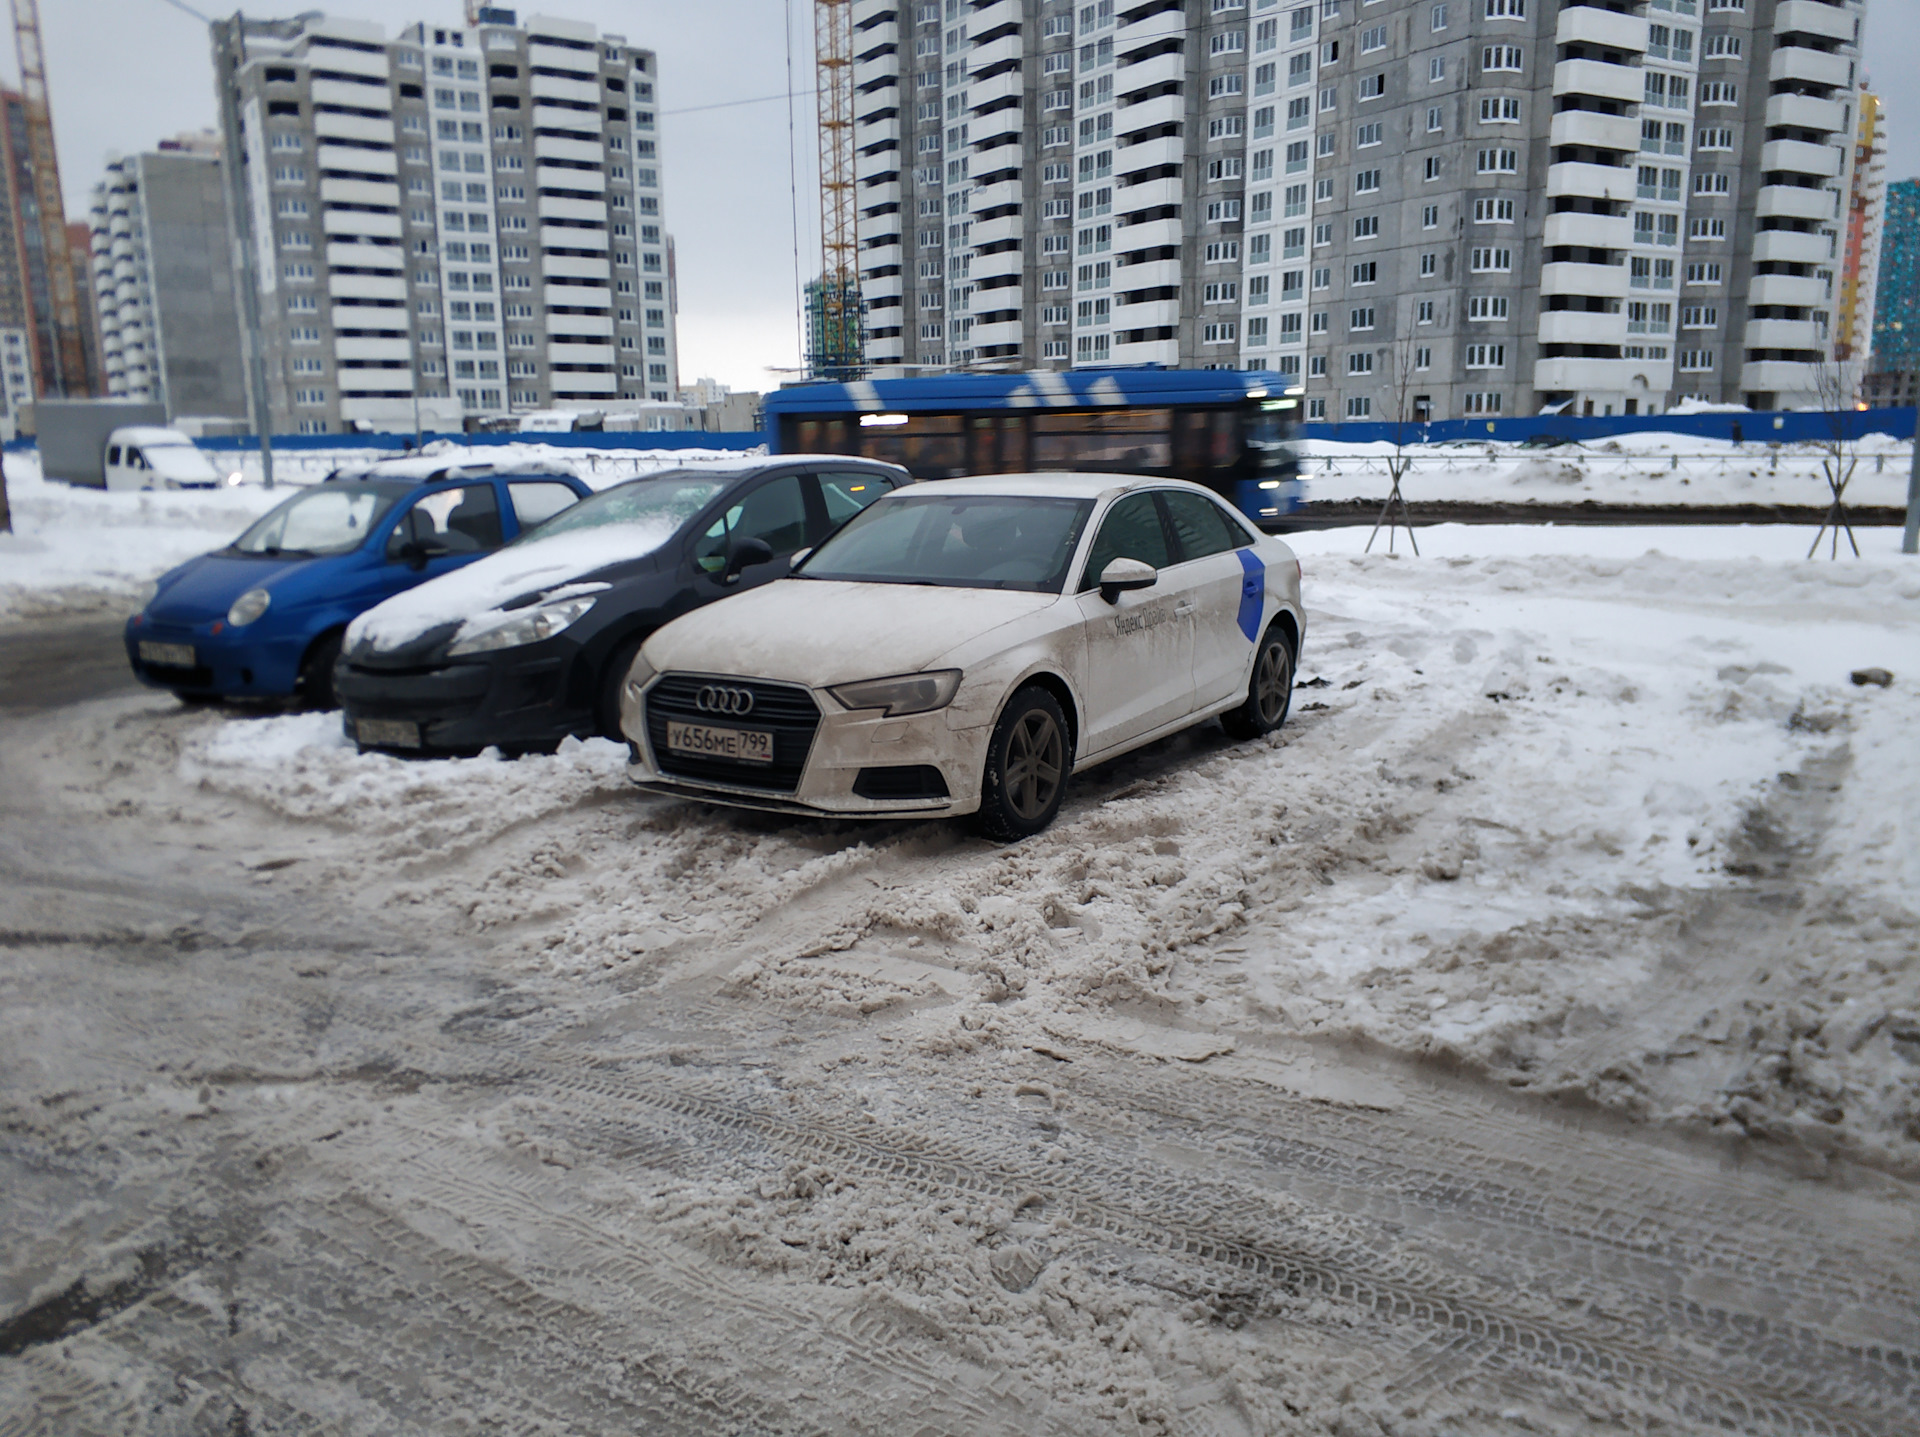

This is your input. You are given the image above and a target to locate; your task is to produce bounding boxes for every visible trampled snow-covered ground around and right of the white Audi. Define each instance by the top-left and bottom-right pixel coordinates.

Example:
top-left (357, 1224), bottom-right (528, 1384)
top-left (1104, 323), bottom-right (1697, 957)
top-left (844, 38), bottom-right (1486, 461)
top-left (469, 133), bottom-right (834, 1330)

top-left (142, 524), bottom-right (1920, 1164)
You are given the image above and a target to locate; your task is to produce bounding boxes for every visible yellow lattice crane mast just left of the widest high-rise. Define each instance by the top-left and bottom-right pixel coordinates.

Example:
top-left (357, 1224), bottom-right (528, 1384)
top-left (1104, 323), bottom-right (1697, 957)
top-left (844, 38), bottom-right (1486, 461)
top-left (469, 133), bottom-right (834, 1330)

top-left (806, 0), bottom-right (864, 380)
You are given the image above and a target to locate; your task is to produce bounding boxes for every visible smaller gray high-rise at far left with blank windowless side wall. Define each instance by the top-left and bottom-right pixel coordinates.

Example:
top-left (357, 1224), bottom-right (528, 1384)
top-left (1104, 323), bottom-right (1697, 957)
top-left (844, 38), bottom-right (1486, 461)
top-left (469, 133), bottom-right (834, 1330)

top-left (88, 131), bottom-right (248, 419)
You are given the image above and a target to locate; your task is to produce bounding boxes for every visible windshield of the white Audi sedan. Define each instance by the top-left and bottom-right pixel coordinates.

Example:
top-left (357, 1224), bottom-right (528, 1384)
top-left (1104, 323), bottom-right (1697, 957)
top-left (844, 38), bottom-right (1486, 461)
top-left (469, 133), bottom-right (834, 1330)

top-left (801, 492), bottom-right (1092, 594)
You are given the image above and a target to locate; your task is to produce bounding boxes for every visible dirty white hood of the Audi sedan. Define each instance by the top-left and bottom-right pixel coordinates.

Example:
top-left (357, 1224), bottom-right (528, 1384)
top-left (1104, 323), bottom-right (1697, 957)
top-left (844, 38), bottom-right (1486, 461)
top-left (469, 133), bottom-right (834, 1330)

top-left (645, 578), bottom-right (1060, 688)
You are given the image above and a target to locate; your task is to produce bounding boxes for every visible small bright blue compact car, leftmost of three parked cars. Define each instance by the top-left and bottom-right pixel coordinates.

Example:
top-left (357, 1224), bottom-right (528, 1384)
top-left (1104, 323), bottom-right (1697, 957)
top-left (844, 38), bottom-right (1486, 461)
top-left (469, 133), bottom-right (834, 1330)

top-left (127, 459), bottom-right (589, 707)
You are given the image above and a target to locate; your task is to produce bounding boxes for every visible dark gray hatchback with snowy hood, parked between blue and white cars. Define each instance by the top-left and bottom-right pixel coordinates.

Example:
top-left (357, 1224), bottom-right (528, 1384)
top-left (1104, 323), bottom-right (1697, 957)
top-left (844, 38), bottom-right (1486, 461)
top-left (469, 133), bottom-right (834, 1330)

top-left (334, 455), bottom-right (912, 753)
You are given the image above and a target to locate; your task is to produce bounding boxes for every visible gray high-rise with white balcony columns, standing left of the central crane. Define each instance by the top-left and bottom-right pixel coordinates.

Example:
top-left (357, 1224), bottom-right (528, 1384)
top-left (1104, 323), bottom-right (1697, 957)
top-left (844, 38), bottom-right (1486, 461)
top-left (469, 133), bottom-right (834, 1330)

top-left (215, 8), bottom-right (678, 432)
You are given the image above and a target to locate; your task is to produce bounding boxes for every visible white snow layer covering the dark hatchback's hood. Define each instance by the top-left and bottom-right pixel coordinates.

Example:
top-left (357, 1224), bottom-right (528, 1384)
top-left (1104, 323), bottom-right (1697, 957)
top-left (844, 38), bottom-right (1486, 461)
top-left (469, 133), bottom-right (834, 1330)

top-left (346, 523), bottom-right (680, 649)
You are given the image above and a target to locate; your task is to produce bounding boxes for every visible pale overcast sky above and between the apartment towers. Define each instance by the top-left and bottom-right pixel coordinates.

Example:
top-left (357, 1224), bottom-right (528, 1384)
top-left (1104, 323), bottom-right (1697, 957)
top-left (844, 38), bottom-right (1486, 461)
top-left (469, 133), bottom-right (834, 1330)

top-left (22, 0), bottom-right (1920, 390)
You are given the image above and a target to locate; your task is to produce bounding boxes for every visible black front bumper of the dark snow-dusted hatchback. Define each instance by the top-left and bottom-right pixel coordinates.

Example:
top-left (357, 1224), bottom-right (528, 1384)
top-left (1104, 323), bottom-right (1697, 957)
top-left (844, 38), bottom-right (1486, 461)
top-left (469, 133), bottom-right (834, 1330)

top-left (334, 645), bottom-right (595, 753)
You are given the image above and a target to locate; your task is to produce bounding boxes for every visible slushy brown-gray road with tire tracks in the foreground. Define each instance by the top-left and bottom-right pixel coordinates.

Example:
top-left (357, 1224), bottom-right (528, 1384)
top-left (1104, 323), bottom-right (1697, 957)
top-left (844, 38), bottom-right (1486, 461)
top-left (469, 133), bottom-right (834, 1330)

top-left (0, 599), bottom-right (1920, 1437)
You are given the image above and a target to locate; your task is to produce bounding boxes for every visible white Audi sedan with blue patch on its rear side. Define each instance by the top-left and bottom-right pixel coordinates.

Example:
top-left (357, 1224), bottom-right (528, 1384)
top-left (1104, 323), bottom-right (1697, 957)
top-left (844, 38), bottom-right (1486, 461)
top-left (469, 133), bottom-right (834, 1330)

top-left (622, 475), bottom-right (1306, 840)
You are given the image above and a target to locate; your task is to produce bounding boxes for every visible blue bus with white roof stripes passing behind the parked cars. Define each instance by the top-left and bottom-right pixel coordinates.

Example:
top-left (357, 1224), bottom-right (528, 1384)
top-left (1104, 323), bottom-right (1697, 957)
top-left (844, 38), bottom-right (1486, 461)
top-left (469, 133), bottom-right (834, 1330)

top-left (766, 367), bottom-right (1302, 528)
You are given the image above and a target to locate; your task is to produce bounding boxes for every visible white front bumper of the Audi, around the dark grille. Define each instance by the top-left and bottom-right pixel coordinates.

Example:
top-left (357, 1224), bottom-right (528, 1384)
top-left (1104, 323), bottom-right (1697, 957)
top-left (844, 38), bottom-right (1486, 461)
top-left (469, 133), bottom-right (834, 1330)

top-left (626, 674), bottom-right (993, 818)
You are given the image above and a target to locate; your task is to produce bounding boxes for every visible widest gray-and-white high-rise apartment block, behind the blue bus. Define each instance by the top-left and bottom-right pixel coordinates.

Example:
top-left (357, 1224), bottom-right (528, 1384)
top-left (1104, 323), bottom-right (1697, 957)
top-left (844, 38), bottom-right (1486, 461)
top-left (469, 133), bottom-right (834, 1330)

top-left (854, 0), bottom-right (1860, 419)
